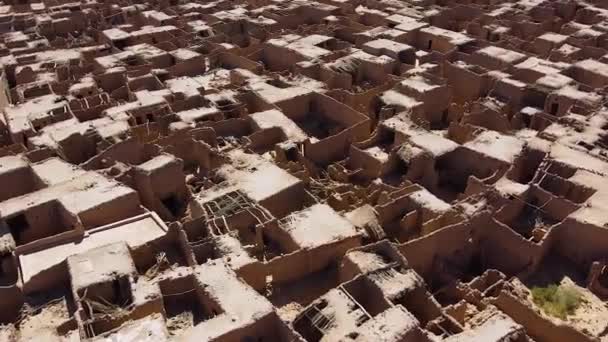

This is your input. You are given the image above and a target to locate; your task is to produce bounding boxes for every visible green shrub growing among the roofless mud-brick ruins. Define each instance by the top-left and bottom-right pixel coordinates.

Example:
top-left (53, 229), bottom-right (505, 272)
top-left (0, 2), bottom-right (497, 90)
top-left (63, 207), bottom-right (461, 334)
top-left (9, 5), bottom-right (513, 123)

top-left (532, 284), bottom-right (582, 319)
